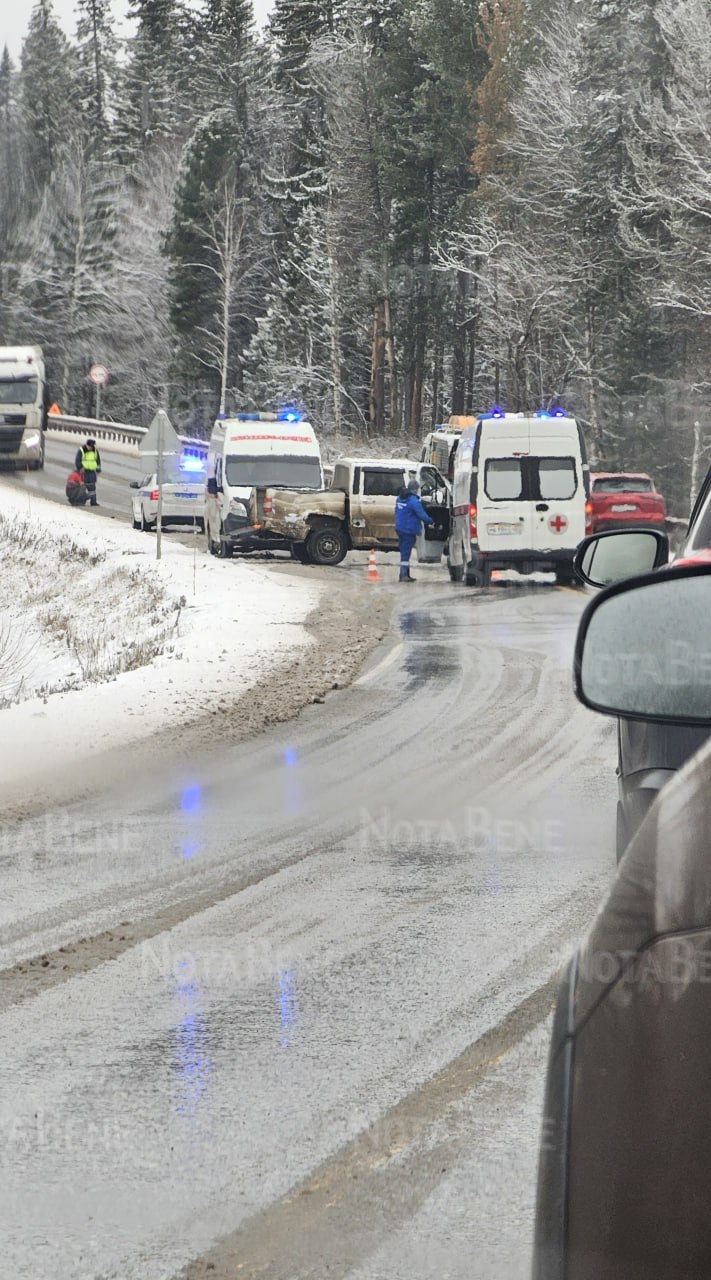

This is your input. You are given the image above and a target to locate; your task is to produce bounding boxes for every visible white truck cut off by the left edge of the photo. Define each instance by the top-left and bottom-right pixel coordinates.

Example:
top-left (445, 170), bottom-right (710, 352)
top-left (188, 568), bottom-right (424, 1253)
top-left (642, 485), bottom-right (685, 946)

top-left (0, 347), bottom-right (50, 471)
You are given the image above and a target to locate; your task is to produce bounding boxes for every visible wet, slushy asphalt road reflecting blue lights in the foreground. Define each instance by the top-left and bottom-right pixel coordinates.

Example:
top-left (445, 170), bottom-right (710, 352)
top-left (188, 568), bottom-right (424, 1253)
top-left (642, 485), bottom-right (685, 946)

top-left (0, 570), bottom-right (615, 1280)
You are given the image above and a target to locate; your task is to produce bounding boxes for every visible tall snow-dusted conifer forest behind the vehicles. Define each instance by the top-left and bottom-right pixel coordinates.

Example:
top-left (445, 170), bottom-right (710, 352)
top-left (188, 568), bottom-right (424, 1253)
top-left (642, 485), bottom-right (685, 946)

top-left (0, 0), bottom-right (711, 508)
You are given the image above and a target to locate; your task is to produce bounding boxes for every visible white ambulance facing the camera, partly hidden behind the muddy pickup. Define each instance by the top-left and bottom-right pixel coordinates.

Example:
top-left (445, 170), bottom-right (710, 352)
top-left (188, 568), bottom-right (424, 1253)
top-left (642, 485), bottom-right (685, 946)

top-left (205, 408), bottom-right (323, 558)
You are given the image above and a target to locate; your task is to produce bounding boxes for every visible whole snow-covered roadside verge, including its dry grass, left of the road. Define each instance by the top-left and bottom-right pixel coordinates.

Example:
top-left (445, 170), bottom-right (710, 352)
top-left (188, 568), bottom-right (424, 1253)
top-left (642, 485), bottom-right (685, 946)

top-left (0, 485), bottom-right (322, 809)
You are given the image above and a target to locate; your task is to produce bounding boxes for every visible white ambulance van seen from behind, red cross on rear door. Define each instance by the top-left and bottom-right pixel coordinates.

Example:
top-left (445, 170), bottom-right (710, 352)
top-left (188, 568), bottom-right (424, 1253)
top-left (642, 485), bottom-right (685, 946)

top-left (447, 410), bottom-right (589, 586)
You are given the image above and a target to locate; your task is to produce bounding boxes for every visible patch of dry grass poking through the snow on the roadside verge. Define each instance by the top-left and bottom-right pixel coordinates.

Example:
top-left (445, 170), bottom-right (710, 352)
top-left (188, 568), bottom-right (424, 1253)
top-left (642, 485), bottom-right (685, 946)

top-left (0, 515), bottom-right (183, 709)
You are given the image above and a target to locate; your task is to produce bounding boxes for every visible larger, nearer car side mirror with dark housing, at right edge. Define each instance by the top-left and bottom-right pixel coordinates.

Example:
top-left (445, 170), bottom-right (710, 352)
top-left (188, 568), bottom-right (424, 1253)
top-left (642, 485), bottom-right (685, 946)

top-left (574, 564), bottom-right (711, 724)
